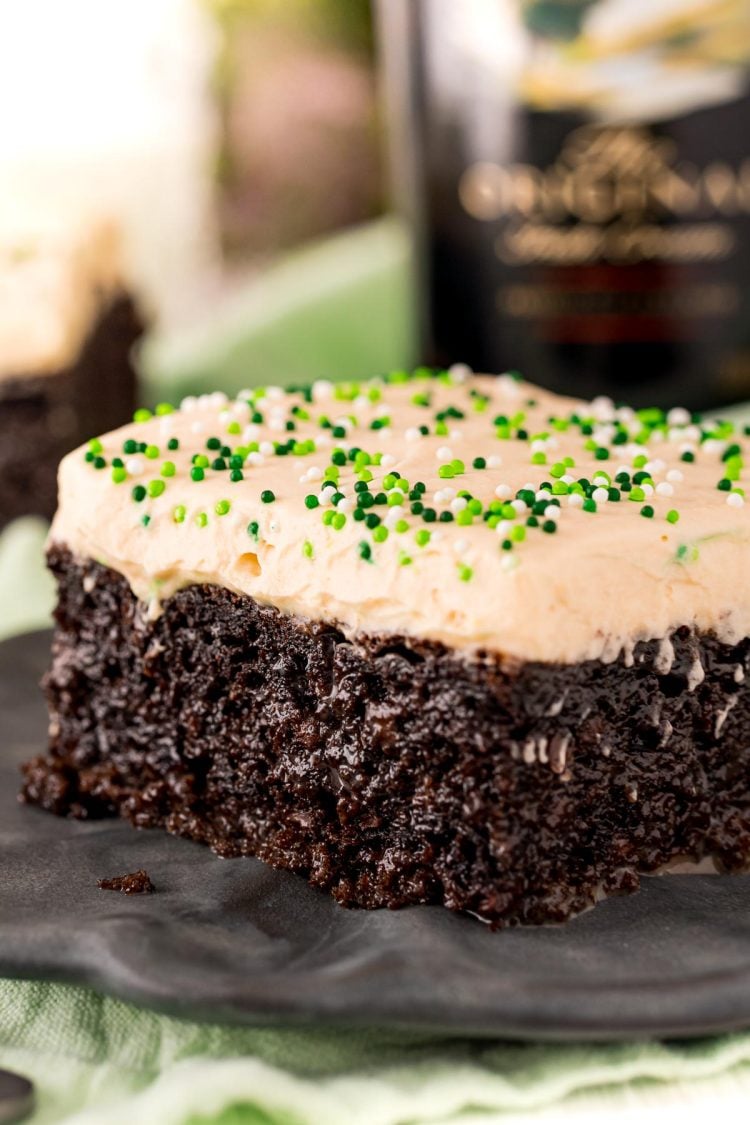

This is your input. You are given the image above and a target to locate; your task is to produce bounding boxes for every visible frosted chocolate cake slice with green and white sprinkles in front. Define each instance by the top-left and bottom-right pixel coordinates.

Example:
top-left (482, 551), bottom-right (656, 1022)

top-left (24, 369), bottom-right (750, 924)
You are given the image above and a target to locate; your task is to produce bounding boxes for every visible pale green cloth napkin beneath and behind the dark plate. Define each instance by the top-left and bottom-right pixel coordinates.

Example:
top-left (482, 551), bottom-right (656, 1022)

top-left (0, 214), bottom-right (750, 1125)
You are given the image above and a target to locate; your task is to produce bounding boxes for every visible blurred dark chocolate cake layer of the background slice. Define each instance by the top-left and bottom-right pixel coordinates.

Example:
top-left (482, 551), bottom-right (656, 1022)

top-left (0, 295), bottom-right (143, 528)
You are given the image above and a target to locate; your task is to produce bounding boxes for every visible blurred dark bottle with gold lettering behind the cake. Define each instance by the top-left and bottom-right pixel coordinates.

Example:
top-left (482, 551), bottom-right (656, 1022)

top-left (380, 0), bottom-right (750, 408)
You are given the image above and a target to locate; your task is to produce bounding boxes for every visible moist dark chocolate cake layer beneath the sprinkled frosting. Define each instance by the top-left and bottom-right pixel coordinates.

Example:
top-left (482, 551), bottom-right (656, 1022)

top-left (22, 547), bottom-right (750, 925)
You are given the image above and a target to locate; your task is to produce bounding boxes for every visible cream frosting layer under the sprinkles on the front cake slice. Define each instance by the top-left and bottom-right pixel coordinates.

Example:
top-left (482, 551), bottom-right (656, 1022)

top-left (51, 370), bottom-right (750, 663)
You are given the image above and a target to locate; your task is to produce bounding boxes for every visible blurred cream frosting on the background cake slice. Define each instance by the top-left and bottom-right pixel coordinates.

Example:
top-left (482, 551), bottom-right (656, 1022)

top-left (0, 219), bottom-right (121, 379)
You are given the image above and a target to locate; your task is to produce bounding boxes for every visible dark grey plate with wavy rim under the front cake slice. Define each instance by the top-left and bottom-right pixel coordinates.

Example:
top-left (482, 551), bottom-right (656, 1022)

top-left (0, 633), bottom-right (750, 1040)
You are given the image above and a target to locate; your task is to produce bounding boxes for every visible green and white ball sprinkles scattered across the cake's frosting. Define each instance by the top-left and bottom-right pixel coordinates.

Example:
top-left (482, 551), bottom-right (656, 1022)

top-left (83, 367), bottom-right (749, 582)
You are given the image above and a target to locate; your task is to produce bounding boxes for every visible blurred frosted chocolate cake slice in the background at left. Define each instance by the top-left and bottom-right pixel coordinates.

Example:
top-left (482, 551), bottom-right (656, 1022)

top-left (0, 222), bottom-right (142, 528)
